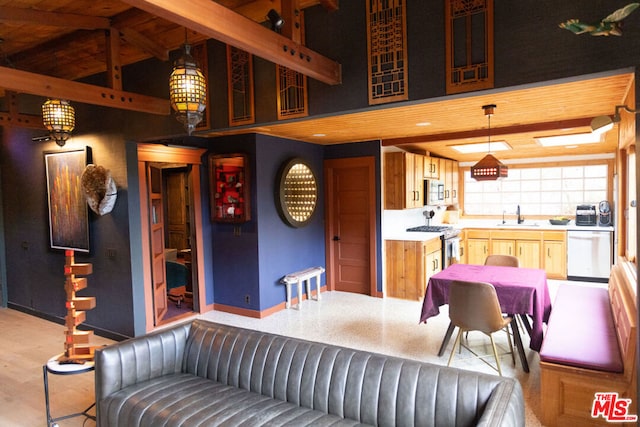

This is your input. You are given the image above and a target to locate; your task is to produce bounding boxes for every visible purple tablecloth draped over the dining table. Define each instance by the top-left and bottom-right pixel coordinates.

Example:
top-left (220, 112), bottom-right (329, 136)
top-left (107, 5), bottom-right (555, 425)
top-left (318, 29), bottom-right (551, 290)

top-left (420, 264), bottom-right (551, 351)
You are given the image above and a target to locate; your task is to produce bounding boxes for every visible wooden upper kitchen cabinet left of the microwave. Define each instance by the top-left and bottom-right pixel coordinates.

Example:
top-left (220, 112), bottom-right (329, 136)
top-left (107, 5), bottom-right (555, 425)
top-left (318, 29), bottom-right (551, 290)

top-left (384, 152), bottom-right (424, 209)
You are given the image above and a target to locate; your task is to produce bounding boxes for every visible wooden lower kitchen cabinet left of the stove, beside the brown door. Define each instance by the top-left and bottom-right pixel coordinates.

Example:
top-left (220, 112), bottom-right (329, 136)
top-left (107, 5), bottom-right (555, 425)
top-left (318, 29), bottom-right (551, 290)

top-left (385, 239), bottom-right (442, 300)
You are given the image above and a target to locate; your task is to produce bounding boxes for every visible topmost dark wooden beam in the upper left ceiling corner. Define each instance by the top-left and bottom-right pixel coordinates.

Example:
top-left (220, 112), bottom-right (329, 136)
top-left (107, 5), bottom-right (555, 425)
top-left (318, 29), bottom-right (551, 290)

top-left (0, 6), bottom-right (111, 30)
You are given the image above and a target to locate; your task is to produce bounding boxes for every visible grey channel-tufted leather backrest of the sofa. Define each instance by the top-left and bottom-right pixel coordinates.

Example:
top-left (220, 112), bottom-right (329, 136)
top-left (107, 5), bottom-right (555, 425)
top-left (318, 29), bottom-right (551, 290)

top-left (183, 320), bottom-right (510, 426)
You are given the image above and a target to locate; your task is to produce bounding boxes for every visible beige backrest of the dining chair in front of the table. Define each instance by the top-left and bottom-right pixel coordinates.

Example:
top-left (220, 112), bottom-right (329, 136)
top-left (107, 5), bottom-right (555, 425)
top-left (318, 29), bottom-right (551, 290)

top-left (449, 280), bottom-right (504, 334)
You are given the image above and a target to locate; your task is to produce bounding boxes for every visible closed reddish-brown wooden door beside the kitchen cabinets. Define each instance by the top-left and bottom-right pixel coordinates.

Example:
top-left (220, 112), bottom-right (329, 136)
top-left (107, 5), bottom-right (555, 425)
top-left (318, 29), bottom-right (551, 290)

top-left (324, 157), bottom-right (377, 295)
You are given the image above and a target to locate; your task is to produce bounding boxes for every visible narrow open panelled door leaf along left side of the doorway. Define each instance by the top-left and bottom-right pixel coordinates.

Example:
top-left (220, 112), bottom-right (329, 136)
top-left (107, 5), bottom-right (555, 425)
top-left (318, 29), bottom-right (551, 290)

top-left (147, 165), bottom-right (167, 325)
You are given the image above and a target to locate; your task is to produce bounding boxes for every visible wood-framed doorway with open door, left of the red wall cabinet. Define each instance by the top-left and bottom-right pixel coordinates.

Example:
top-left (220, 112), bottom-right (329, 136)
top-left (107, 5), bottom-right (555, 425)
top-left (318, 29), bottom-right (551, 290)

top-left (138, 144), bottom-right (206, 331)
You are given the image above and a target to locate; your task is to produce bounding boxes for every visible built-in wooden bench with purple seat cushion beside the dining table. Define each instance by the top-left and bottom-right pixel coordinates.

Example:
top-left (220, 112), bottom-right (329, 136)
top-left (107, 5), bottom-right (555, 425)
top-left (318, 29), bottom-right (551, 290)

top-left (540, 260), bottom-right (638, 427)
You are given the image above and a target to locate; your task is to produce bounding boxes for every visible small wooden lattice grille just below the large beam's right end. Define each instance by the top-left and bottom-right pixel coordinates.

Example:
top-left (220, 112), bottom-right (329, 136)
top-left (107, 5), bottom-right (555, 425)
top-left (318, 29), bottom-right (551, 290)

top-left (276, 65), bottom-right (309, 120)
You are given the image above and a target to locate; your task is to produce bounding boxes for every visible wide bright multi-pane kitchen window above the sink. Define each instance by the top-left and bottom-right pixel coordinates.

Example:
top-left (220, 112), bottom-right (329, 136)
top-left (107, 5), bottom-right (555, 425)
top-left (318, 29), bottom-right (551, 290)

top-left (463, 163), bottom-right (613, 216)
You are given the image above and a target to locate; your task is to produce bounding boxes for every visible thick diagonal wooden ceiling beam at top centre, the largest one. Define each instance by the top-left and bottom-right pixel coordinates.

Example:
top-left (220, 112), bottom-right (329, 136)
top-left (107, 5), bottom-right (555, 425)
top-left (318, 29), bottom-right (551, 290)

top-left (124, 0), bottom-right (341, 85)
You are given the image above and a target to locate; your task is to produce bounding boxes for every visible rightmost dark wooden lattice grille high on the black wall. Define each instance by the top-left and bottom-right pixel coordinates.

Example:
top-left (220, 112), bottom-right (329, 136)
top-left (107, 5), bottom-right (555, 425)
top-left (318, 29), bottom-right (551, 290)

top-left (445, 0), bottom-right (494, 94)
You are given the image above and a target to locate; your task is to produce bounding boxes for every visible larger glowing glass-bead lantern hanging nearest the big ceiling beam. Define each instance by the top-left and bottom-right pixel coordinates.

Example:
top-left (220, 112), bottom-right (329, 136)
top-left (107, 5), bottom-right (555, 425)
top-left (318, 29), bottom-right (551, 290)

top-left (169, 43), bottom-right (207, 135)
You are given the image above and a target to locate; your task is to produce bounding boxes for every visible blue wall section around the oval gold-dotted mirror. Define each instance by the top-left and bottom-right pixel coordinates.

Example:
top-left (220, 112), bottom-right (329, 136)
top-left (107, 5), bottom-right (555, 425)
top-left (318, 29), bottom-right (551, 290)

top-left (256, 135), bottom-right (325, 310)
